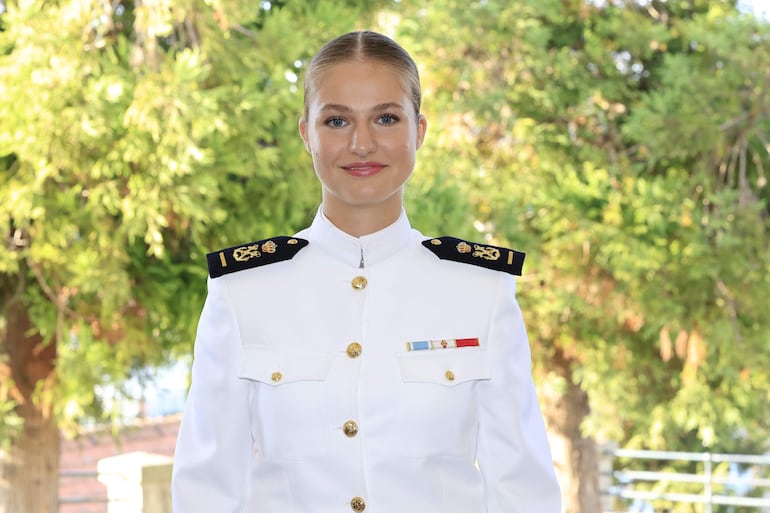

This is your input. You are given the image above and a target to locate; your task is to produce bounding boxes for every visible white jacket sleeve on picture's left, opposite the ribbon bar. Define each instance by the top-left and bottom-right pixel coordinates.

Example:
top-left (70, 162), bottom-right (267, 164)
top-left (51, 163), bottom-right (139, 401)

top-left (171, 278), bottom-right (252, 513)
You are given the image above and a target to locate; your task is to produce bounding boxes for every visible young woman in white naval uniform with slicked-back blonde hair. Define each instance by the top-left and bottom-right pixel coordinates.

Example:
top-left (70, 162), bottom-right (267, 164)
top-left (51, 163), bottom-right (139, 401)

top-left (172, 32), bottom-right (560, 513)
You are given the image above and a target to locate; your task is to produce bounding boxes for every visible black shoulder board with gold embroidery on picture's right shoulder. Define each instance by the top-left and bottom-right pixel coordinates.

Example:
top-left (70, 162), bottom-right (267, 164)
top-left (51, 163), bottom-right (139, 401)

top-left (422, 237), bottom-right (524, 276)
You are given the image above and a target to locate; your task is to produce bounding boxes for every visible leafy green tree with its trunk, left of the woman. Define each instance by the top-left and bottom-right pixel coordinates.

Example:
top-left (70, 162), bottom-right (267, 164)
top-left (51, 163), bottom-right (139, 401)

top-left (0, 0), bottom-right (384, 512)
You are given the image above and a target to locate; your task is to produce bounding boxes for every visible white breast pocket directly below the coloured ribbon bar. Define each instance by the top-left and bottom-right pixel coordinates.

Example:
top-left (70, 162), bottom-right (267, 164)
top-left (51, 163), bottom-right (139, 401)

top-left (397, 348), bottom-right (491, 457)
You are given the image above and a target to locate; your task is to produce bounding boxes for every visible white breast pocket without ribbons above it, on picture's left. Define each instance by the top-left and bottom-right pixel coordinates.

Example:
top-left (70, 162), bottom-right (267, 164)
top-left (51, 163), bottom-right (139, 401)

top-left (239, 346), bottom-right (333, 459)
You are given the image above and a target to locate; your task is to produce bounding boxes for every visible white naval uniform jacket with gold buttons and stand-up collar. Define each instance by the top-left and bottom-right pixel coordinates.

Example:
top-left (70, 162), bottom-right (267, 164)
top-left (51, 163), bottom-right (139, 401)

top-left (172, 210), bottom-right (560, 513)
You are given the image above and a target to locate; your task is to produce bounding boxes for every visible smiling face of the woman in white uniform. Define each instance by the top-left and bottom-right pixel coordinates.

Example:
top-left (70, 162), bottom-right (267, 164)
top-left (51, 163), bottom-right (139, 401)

top-left (299, 61), bottom-right (426, 226)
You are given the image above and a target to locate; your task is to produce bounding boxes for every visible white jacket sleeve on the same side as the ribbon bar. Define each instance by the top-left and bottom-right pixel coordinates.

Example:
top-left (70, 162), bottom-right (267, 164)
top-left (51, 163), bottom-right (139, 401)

top-left (477, 273), bottom-right (561, 513)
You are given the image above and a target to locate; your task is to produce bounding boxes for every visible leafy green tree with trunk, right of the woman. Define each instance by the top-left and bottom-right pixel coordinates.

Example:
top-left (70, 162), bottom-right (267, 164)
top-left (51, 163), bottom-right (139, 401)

top-left (390, 0), bottom-right (770, 512)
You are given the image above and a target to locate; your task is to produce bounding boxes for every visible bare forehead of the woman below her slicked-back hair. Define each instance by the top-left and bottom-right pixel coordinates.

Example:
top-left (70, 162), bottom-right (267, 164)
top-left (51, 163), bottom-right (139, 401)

top-left (308, 60), bottom-right (409, 109)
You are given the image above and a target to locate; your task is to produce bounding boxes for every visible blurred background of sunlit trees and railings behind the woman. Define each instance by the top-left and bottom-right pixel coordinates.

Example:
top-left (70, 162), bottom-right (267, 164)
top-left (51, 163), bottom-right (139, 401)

top-left (0, 0), bottom-right (770, 513)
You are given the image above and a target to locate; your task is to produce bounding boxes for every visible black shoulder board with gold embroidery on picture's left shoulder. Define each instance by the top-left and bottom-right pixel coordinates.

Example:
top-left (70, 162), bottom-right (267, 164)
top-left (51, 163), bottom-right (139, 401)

top-left (206, 236), bottom-right (308, 278)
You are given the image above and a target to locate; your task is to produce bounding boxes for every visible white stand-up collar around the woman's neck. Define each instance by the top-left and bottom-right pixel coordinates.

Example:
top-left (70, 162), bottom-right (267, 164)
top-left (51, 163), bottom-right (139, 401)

top-left (306, 206), bottom-right (412, 268)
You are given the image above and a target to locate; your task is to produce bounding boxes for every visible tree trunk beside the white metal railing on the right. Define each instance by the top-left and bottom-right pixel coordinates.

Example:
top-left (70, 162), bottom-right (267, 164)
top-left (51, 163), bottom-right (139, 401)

top-left (543, 350), bottom-right (602, 513)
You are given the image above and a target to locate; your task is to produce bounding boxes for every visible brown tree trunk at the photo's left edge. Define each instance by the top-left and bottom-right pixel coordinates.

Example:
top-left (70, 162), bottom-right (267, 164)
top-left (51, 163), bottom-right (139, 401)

top-left (0, 294), bottom-right (60, 513)
